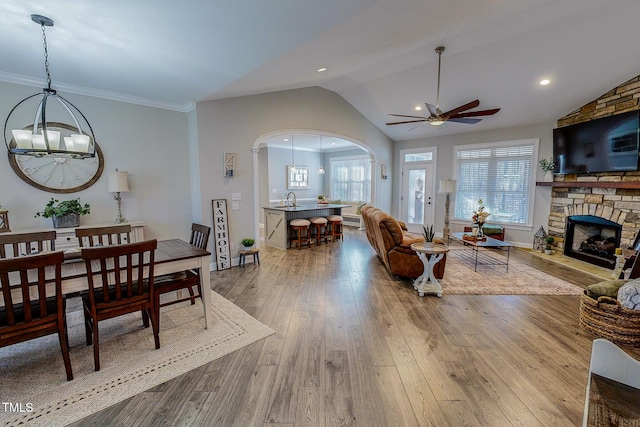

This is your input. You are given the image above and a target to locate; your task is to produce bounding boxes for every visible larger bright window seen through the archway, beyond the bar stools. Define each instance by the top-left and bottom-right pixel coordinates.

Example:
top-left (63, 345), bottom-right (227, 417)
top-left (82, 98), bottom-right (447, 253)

top-left (331, 157), bottom-right (371, 202)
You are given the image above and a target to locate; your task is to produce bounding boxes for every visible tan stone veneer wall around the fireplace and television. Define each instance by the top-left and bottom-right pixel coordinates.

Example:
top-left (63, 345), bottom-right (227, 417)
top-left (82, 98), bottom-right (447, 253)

top-left (549, 76), bottom-right (640, 252)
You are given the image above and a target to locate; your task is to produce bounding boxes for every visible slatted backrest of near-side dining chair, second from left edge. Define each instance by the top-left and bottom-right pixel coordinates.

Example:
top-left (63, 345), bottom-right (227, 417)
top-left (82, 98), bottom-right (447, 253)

top-left (81, 239), bottom-right (158, 307)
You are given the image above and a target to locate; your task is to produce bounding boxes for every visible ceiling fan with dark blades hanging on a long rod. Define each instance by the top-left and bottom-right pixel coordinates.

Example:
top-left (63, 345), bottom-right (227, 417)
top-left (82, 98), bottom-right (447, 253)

top-left (387, 46), bottom-right (500, 126)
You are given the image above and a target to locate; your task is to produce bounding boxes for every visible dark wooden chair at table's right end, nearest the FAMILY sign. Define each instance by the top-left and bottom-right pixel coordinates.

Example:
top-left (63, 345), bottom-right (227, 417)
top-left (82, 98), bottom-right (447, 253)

top-left (154, 223), bottom-right (211, 313)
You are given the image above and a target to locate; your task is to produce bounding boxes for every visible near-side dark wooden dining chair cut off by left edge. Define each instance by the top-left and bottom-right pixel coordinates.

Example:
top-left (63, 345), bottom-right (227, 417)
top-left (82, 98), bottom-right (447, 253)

top-left (0, 251), bottom-right (73, 381)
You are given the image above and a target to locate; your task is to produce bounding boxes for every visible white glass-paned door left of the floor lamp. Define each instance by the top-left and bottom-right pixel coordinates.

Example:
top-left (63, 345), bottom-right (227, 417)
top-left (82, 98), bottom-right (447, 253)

top-left (400, 162), bottom-right (434, 232)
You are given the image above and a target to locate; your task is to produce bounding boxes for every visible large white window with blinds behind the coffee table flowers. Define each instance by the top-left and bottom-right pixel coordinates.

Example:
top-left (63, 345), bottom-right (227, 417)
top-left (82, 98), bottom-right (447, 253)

top-left (454, 139), bottom-right (538, 226)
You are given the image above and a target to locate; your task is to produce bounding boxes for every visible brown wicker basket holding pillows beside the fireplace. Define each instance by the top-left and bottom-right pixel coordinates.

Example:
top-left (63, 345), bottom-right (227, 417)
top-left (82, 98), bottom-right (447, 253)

top-left (580, 291), bottom-right (640, 347)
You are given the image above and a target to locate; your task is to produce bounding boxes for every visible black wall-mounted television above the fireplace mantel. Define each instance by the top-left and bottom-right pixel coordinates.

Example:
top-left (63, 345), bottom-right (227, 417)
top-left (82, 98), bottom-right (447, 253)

top-left (553, 111), bottom-right (640, 173)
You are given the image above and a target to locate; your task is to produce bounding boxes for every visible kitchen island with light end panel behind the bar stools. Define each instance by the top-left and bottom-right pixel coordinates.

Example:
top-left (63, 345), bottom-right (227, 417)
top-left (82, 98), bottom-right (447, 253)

top-left (263, 203), bottom-right (351, 249)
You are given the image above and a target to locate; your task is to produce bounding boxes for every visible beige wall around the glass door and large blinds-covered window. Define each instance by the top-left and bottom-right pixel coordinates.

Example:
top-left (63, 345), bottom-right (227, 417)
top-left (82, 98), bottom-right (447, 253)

top-left (392, 123), bottom-right (555, 246)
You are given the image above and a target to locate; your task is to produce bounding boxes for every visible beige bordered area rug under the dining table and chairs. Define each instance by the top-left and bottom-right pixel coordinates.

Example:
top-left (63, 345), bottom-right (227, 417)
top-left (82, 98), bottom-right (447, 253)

top-left (0, 292), bottom-right (274, 426)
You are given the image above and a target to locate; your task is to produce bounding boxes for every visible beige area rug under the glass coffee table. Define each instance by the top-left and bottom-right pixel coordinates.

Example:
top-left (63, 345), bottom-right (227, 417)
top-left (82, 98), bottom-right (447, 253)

top-left (440, 249), bottom-right (582, 295)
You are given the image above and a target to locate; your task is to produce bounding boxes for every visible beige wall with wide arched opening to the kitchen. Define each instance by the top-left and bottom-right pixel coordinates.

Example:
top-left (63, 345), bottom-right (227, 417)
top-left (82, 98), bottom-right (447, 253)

top-left (197, 87), bottom-right (393, 256)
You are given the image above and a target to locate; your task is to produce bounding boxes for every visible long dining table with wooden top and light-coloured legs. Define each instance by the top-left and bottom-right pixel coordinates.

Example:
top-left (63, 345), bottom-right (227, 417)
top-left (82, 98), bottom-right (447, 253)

top-left (0, 239), bottom-right (212, 329)
